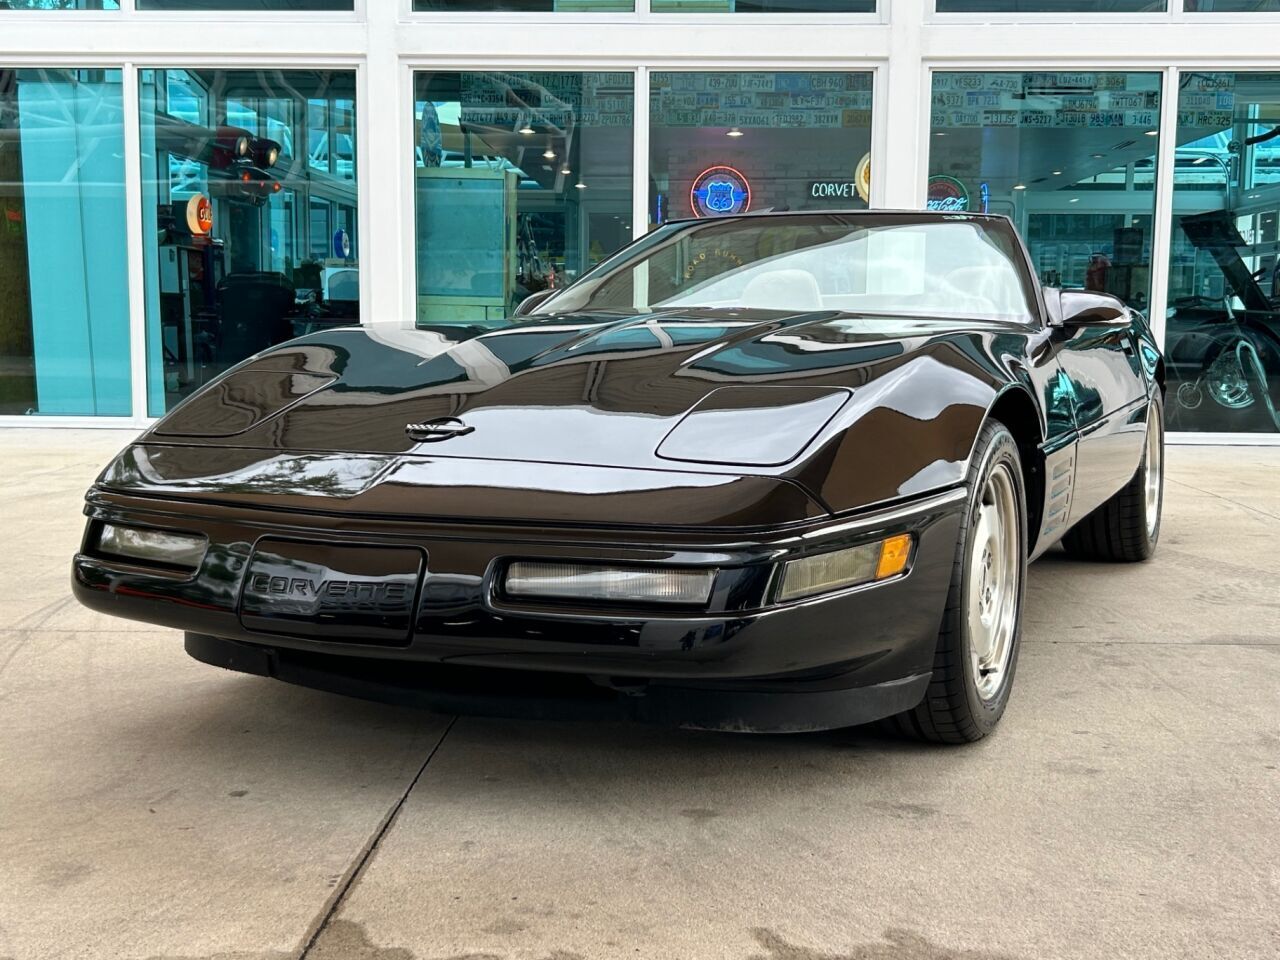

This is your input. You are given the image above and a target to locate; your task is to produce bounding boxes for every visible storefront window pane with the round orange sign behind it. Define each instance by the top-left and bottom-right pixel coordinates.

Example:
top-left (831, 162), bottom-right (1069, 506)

top-left (140, 69), bottom-right (360, 416)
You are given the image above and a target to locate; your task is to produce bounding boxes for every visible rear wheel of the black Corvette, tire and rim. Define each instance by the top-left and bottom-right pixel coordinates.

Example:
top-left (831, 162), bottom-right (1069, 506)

top-left (1062, 394), bottom-right (1165, 563)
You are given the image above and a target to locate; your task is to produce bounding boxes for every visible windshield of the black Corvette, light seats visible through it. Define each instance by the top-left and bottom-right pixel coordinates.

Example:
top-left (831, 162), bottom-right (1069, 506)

top-left (532, 214), bottom-right (1032, 323)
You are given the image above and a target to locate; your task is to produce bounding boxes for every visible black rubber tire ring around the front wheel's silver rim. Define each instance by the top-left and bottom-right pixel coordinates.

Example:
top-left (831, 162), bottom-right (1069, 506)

top-left (954, 421), bottom-right (1027, 735)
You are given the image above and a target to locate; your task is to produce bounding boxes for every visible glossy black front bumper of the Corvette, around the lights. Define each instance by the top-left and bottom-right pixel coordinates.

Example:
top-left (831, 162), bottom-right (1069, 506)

top-left (73, 488), bottom-right (966, 728)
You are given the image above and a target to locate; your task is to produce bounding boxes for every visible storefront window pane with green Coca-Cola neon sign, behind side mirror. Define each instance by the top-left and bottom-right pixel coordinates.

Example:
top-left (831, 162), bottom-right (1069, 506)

top-left (928, 72), bottom-right (1160, 310)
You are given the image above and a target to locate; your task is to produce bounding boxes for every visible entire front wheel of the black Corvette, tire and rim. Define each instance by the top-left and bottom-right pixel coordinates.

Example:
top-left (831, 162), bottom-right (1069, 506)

top-left (892, 420), bottom-right (1027, 744)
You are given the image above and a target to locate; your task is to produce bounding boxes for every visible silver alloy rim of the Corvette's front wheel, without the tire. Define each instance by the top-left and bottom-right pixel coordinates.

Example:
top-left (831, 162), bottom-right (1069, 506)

top-left (966, 463), bottom-right (1021, 700)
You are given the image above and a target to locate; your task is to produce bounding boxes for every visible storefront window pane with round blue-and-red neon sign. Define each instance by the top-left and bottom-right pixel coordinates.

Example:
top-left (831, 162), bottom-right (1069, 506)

top-left (649, 72), bottom-right (872, 225)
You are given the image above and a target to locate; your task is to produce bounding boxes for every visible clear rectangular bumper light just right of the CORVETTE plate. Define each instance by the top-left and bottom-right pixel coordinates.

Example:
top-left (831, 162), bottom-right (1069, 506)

top-left (503, 561), bottom-right (716, 604)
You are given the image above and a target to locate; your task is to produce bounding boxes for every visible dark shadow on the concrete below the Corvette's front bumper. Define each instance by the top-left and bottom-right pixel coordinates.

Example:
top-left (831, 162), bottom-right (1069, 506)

top-left (107, 676), bottom-right (954, 798)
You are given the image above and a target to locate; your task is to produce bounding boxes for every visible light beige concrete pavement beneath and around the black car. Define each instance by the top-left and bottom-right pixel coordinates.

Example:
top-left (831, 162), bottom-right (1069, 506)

top-left (0, 430), bottom-right (1280, 960)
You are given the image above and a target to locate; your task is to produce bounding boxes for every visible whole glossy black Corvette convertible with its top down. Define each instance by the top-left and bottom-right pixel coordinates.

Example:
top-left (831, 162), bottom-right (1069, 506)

top-left (74, 212), bottom-right (1165, 742)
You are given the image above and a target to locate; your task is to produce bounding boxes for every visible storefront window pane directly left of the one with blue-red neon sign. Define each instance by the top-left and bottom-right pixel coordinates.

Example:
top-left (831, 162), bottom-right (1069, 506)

top-left (415, 72), bottom-right (635, 326)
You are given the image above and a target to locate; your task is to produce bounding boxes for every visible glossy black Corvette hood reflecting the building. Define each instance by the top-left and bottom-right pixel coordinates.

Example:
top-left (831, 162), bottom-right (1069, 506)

top-left (135, 310), bottom-right (1027, 519)
